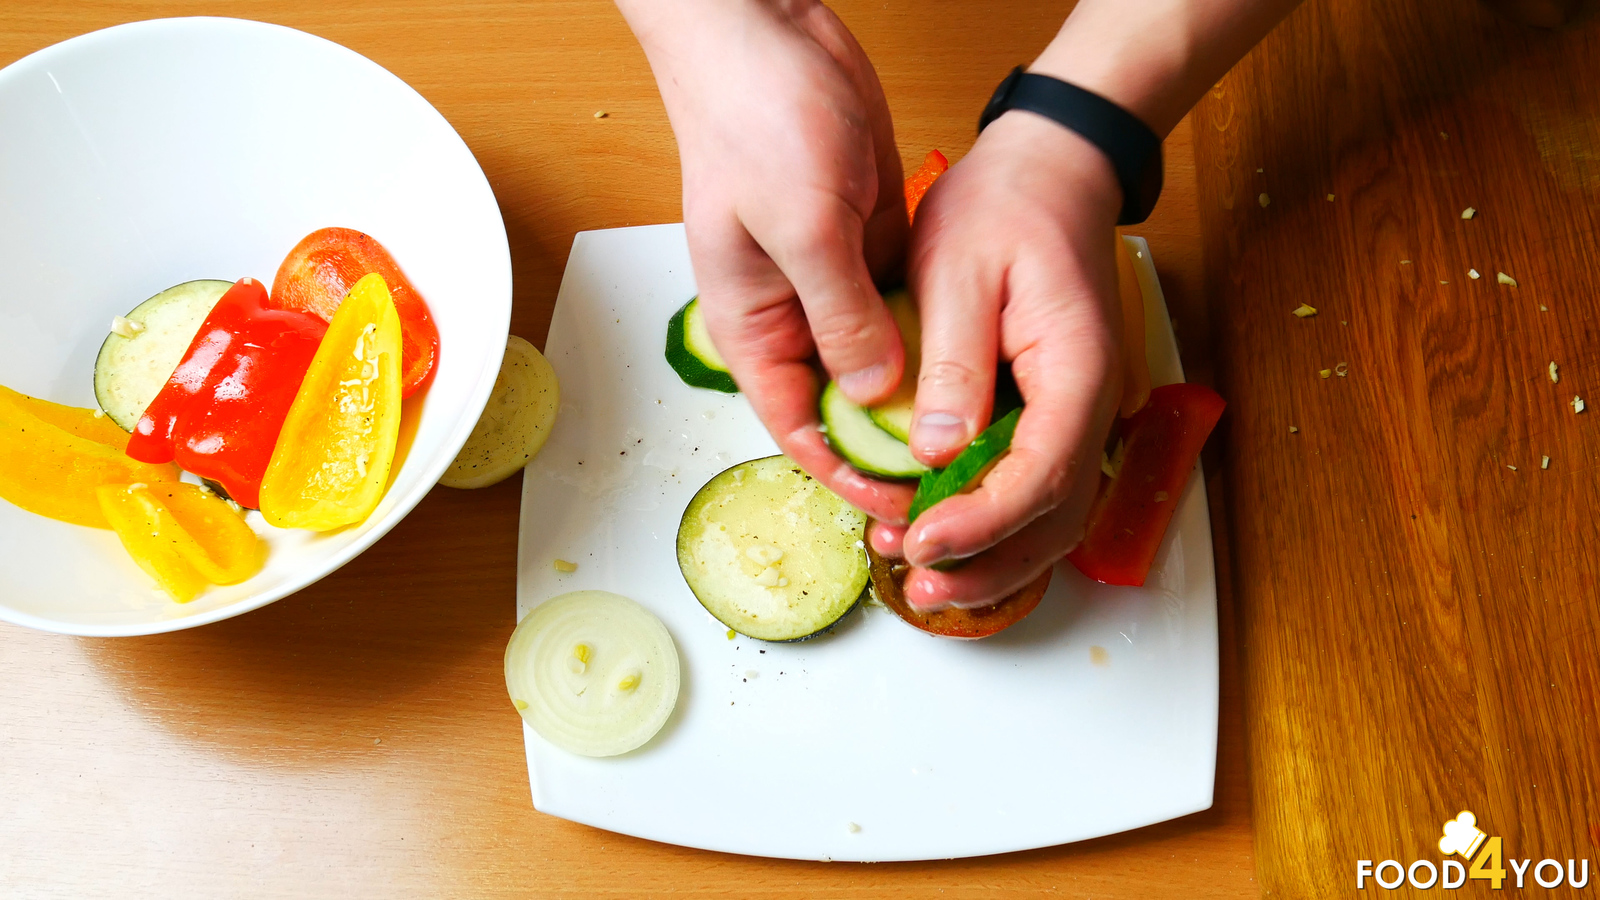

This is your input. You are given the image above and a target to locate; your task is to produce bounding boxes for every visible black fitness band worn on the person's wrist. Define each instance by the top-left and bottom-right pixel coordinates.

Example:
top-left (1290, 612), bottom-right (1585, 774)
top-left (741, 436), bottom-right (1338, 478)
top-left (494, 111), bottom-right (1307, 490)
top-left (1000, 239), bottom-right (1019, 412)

top-left (978, 66), bottom-right (1162, 224)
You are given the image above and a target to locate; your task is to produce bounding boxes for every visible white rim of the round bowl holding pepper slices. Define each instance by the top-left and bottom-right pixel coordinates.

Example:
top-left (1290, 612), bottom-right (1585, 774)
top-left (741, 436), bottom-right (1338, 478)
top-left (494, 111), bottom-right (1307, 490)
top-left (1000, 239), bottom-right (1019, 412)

top-left (0, 16), bottom-right (514, 637)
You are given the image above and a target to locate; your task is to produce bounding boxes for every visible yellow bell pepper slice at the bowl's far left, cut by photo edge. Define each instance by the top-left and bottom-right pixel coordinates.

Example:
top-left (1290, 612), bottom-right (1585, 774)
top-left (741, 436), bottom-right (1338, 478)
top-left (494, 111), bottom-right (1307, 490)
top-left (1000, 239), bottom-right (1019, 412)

top-left (0, 388), bottom-right (178, 528)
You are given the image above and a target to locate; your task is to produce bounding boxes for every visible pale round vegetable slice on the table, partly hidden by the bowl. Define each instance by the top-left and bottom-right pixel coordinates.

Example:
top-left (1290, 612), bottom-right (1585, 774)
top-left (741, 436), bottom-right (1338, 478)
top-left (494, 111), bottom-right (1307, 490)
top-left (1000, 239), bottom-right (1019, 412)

top-left (438, 335), bottom-right (562, 488)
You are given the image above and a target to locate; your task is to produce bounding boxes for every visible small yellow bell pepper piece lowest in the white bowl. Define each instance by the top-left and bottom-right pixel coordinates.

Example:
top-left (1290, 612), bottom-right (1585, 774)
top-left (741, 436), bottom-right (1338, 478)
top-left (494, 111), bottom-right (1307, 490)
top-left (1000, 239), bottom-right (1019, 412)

top-left (96, 482), bottom-right (266, 604)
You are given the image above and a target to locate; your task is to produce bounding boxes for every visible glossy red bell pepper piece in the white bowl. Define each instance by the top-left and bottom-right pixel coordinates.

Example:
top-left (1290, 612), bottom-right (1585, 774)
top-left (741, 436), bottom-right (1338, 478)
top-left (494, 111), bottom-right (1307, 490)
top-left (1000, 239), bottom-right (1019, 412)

top-left (128, 279), bottom-right (328, 509)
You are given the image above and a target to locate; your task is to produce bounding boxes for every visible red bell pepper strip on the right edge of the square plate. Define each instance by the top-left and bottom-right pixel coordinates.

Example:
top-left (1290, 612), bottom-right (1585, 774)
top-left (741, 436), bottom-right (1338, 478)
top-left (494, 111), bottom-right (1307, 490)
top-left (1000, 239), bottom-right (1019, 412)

top-left (1067, 384), bottom-right (1227, 585)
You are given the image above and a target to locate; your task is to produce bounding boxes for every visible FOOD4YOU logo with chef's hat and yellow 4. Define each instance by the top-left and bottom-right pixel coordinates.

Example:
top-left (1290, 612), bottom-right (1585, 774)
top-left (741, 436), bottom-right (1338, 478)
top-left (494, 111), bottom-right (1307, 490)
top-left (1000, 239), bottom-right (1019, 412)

top-left (1355, 809), bottom-right (1589, 890)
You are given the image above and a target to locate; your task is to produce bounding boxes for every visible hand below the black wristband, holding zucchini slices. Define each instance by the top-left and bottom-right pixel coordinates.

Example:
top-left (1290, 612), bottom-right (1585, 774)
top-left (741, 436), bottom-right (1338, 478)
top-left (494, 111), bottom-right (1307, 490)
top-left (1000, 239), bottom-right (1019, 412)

top-left (870, 112), bottom-right (1122, 609)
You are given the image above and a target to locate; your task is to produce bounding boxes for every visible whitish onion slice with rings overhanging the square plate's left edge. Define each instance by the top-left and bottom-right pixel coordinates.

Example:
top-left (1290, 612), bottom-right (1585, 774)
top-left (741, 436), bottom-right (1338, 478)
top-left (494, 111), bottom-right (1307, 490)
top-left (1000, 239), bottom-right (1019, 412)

top-left (506, 591), bottom-right (680, 756)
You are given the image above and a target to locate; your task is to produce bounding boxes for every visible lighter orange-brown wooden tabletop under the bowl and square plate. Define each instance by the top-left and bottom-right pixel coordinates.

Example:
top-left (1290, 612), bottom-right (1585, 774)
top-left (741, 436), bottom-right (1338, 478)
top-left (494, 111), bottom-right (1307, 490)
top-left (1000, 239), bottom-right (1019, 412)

top-left (0, 0), bottom-right (1254, 898)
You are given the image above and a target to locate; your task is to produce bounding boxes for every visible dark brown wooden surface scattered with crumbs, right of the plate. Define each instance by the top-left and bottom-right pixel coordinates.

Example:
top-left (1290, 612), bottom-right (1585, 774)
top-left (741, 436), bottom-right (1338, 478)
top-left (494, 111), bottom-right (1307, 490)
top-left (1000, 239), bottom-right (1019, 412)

top-left (1194, 0), bottom-right (1600, 897)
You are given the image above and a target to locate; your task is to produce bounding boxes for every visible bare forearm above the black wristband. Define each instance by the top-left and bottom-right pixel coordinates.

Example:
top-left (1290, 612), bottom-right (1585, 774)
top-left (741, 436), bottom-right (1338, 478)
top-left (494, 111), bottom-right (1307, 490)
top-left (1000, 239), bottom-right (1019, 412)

top-left (1029, 0), bottom-right (1299, 136)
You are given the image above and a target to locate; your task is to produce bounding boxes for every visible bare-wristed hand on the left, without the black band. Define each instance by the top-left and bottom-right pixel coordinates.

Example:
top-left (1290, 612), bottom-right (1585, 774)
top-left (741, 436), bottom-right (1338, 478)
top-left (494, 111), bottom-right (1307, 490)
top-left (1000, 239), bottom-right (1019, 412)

top-left (619, 0), bottom-right (912, 522)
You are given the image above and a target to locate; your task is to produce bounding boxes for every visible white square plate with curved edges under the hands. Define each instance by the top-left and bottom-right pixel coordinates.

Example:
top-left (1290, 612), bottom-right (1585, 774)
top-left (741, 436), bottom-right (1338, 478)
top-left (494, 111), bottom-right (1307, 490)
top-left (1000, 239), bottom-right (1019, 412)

top-left (517, 224), bottom-right (1218, 860)
